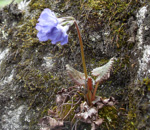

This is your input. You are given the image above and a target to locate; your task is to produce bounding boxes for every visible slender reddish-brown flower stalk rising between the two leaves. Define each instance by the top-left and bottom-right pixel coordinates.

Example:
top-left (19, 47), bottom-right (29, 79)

top-left (74, 21), bottom-right (87, 79)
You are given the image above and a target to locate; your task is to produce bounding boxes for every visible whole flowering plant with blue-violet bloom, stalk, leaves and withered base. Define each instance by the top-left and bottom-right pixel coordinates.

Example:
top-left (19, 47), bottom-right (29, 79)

top-left (36, 9), bottom-right (117, 130)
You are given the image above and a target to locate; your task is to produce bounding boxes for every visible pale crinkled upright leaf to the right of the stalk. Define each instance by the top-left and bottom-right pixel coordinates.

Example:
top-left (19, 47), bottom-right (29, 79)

top-left (91, 58), bottom-right (114, 82)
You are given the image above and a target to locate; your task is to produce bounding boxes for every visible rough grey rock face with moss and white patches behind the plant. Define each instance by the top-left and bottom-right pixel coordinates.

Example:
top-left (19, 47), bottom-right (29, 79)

top-left (0, 0), bottom-right (150, 130)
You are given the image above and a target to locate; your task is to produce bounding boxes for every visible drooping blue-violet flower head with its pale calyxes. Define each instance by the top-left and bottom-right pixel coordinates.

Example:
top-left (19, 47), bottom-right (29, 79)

top-left (36, 8), bottom-right (74, 45)
